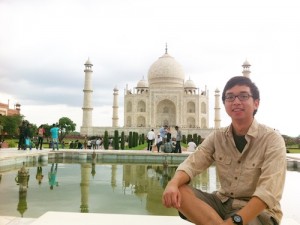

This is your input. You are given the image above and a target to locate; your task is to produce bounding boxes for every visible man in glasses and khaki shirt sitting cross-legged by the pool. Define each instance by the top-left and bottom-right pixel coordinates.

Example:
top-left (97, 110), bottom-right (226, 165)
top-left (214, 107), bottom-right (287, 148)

top-left (162, 76), bottom-right (286, 225)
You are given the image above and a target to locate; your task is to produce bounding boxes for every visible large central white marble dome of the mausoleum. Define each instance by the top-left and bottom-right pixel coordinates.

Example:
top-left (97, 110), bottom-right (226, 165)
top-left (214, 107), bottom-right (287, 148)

top-left (148, 53), bottom-right (185, 87)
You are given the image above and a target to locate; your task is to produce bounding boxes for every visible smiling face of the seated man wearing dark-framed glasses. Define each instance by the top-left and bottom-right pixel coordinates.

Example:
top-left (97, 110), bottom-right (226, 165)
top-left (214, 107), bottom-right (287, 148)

top-left (224, 85), bottom-right (259, 120)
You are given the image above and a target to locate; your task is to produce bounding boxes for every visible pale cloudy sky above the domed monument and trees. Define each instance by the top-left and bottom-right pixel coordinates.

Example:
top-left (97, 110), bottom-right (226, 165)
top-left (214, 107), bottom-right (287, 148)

top-left (0, 0), bottom-right (300, 136)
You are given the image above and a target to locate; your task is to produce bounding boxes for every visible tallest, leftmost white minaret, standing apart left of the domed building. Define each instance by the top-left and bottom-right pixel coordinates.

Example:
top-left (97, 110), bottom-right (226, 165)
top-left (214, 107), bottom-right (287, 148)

top-left (81, 59), bottom-right (93, 135)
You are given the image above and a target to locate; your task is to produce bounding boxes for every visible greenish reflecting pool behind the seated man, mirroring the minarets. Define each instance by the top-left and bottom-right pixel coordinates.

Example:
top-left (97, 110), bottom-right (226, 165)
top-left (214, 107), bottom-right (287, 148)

top-left (0, 163), bottom-right (300, 222)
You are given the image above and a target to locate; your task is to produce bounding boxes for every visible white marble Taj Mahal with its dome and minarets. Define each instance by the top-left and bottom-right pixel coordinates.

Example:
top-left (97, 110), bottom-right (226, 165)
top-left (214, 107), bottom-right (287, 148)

top-left (80, 47), bottom-right (251, 138)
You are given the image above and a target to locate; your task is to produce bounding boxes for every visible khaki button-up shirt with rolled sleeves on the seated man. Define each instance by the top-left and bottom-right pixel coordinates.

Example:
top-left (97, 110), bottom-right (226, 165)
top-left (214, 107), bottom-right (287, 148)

top-left (177, 120), bottom-right (286, 221)
